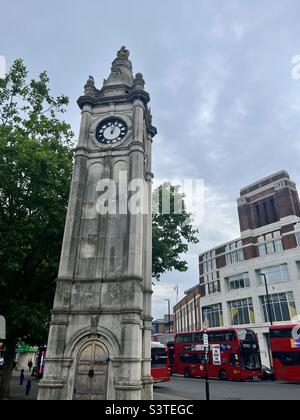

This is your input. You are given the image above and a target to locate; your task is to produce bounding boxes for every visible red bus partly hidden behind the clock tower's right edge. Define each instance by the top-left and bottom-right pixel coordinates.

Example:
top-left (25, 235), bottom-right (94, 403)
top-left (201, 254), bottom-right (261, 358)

top-left (151, 342), bottom-right (171, 383)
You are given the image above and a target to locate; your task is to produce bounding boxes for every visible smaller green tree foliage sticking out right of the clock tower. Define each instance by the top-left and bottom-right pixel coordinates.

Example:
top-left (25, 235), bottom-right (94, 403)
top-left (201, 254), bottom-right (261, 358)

top-left (152, 183), bottom-right (199, 281)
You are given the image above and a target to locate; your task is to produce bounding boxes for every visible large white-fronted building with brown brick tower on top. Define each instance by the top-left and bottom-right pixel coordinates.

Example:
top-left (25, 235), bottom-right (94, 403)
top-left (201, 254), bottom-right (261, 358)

top-left (199, 171), bottom-right (300, 364)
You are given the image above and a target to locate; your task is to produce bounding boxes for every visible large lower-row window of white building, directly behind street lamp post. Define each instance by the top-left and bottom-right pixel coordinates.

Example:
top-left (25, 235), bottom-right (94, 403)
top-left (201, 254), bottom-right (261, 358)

top-left (261, 292), bottom-right (297, 322)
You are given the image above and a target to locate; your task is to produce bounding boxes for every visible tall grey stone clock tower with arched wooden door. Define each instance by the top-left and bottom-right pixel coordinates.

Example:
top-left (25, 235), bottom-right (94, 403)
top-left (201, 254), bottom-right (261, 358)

top-left (39, 47), bottom-right (157, 400)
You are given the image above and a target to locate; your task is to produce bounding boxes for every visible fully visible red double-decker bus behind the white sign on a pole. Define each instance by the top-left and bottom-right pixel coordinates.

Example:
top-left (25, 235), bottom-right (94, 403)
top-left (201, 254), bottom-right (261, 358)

top-left (174, 328), bottom-right (263, 381)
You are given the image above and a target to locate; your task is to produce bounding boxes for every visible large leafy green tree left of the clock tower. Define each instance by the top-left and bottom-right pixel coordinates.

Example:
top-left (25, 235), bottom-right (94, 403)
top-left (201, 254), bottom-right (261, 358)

top-left (0, 60), bottom-right (73, 399)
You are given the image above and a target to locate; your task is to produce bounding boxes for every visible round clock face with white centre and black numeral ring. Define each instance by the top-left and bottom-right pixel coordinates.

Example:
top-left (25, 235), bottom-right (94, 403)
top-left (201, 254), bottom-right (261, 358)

top-left (96, 117), bottom-right (128, 145)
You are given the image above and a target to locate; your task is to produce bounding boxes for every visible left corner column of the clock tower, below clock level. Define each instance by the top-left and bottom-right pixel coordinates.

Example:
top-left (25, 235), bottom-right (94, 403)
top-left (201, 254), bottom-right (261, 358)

top-left (38, 153), bottom-right (87, 400)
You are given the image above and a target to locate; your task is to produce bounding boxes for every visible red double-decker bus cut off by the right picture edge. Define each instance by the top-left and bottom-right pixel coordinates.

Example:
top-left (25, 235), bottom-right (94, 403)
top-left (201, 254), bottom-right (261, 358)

top-left (270, 325), bottom-right (300, 382)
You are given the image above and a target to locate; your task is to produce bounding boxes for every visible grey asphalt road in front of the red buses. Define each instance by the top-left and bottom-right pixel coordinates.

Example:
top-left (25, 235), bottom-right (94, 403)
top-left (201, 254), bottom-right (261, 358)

top-left (154, 376), bottom-right (300, 401)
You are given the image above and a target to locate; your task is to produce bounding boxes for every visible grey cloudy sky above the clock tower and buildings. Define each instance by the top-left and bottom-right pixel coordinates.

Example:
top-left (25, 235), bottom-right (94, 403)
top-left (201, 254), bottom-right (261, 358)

top-left (0, 0), bottom-right (300, 317)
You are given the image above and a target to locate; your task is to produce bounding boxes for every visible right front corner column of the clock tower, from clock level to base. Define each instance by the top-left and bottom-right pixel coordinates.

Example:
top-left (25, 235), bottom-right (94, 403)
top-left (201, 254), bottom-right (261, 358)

top-left (115, 101), bottom-right (144, 400)
